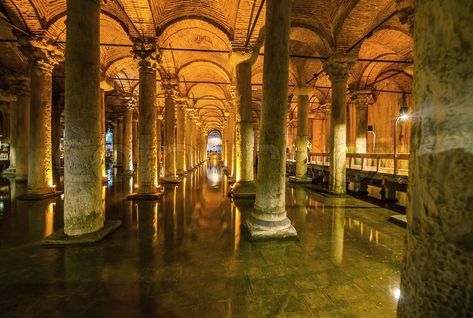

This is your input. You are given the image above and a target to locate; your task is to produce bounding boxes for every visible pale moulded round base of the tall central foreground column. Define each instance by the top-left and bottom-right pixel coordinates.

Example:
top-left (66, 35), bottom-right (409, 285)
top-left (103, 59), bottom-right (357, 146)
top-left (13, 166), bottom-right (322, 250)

top-left (245, 216), bottom-right (297, 241)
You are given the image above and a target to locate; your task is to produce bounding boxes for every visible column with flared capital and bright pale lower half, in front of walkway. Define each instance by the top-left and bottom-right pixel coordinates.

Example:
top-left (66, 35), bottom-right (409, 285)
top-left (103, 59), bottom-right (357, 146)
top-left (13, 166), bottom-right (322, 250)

top-left (324, 53), bottom-right (356, 194)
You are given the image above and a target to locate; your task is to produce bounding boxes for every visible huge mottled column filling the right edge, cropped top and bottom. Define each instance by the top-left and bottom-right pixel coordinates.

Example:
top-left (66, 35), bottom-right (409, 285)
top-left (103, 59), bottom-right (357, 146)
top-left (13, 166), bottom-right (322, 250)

top-left (397, 0), bottom-right (473, 318)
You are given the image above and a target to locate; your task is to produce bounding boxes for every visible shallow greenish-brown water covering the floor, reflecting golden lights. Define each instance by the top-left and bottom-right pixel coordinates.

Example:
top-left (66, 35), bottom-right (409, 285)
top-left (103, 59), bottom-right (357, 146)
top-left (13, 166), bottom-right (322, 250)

top-left (0, 164), bottom-right (404, 317)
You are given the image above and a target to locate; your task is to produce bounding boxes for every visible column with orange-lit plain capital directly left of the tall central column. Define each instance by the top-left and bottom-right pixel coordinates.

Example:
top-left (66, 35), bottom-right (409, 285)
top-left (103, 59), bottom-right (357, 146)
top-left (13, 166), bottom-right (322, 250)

top-left (230, 49), bottom-right (258, 198)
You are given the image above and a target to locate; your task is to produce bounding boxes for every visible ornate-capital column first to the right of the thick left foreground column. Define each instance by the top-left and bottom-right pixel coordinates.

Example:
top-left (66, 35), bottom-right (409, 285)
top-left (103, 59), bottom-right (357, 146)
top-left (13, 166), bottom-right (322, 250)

top-left (128, 39), bottom-right (162, 200)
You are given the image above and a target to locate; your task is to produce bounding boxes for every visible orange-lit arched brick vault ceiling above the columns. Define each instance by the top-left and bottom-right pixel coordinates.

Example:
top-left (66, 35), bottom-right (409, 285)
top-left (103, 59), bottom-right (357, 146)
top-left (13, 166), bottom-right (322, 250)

top-left (0, 0), bottom-right (413, 129)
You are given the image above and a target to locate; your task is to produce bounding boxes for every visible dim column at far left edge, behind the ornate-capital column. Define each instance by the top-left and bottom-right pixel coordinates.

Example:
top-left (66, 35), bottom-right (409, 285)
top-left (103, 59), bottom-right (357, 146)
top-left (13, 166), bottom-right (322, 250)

top-left (10, 77), bottom-right (30, 182)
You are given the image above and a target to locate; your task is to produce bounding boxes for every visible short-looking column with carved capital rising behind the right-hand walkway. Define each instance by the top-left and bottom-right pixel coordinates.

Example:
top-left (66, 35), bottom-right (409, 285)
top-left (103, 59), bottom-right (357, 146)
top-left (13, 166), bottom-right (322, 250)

top-left (351, 90), bottom-right (374, 153)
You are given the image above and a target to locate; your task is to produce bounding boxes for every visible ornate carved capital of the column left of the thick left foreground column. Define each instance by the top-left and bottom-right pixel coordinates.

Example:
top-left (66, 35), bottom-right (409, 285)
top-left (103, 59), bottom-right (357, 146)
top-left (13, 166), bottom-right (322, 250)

top-left (18, 34), bottom-right (64, 73)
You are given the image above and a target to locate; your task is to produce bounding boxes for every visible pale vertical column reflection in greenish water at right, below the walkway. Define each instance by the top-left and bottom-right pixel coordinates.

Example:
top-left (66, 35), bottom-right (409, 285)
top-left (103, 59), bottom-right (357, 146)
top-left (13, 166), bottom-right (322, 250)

top-left (332, 198), bottom-right (345, 265)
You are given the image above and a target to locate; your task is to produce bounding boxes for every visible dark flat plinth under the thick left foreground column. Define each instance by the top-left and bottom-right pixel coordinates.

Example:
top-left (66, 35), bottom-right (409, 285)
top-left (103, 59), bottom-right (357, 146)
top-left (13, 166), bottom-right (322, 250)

top-left (42, 220), bottom-right (122, 246)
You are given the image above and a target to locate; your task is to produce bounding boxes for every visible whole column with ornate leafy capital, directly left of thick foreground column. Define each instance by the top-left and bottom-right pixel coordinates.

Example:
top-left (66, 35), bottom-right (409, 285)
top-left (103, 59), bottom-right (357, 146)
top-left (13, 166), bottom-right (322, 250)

top-left (20, 38), bottom-right (62, 200)
